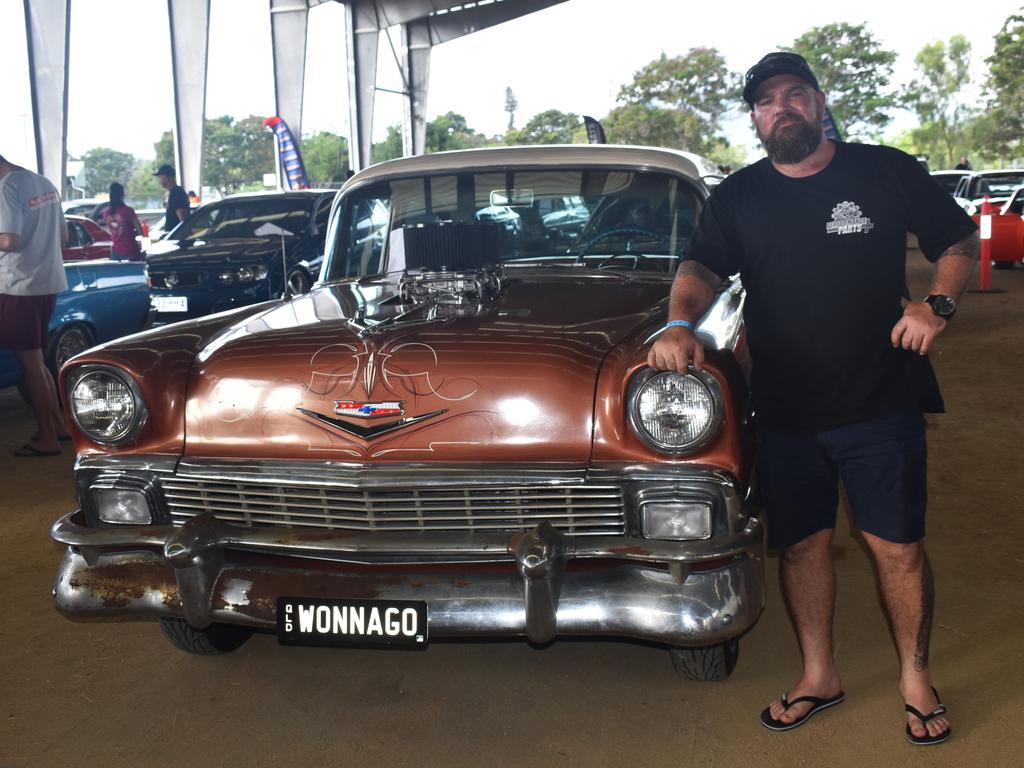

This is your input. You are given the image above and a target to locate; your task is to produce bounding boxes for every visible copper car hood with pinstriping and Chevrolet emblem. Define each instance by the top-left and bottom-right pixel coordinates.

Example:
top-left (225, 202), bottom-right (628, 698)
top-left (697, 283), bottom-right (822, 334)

top-left (185, 269), bottom-right (670, 464)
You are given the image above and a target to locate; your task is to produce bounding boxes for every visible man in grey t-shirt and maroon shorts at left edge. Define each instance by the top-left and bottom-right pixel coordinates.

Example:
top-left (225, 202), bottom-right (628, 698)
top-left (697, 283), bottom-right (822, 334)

top-left (0, 155), bottom-right (69, 457)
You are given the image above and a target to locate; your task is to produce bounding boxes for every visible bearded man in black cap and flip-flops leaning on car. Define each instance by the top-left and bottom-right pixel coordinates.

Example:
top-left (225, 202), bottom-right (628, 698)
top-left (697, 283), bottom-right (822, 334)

top-left (648, 51), bottom-right (978, 744)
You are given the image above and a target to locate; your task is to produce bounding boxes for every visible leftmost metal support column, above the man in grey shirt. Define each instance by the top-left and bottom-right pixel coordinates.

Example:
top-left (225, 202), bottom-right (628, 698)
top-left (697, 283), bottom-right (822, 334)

top-left (25, 0), bottom-right (71, 197)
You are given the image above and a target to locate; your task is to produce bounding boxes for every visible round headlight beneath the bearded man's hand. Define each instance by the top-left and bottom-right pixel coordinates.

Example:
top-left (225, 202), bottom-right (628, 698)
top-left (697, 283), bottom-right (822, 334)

top-left (629, 370), bottom-right (722, 454)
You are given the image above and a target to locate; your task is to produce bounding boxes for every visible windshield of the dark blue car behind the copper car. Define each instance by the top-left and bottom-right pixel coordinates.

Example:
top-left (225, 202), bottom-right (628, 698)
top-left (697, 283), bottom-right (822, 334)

top-left (174, 197), bottom-right (312, 240)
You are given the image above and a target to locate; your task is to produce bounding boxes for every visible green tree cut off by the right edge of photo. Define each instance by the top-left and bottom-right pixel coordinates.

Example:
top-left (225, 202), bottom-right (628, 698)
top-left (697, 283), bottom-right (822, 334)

top-left (979, 13), bottom-right (1024, 165)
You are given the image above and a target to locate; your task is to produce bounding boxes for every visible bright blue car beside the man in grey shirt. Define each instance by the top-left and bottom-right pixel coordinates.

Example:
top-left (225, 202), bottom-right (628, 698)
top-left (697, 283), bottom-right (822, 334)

top-left (0, 259), bottom-right (150, 388)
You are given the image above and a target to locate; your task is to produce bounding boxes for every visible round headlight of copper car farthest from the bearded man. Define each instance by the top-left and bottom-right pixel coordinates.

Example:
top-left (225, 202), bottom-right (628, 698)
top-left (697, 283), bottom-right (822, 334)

top-left (70, 370), bottom-right (145, 442)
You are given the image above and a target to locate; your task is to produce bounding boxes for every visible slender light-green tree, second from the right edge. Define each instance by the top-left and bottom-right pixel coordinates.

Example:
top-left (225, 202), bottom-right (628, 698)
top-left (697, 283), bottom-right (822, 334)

top-left (903, 35), bottom-right (972, 168)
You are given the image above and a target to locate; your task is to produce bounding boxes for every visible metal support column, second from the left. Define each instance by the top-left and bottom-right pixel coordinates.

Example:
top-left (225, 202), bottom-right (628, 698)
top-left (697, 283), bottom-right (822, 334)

top-left (167, 0), bottom-right (210, 194)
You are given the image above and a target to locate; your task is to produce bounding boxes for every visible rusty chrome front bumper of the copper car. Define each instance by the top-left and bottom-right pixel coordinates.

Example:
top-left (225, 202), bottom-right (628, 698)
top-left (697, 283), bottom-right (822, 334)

top-left (51, 512), bottom-right (765, 646)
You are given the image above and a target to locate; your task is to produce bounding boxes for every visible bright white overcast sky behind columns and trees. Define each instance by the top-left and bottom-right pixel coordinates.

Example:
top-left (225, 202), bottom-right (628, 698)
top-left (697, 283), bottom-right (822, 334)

top-left (0, 0), bottom-right (1021, 167)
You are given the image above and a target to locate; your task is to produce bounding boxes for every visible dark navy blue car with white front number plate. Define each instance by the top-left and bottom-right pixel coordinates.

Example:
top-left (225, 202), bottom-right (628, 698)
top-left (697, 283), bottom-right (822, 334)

top-left (145, 189), bottom-right (335, 325)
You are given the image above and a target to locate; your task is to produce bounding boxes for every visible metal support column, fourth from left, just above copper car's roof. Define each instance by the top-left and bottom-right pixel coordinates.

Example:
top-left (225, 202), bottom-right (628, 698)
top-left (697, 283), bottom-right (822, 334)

top-left (345, 0), bottom-right (380, 171)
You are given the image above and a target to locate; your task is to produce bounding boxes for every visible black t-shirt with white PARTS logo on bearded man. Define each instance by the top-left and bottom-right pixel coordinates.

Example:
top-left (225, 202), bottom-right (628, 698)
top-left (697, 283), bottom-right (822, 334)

top-left (686, 143), bottom-right (975, 431)
